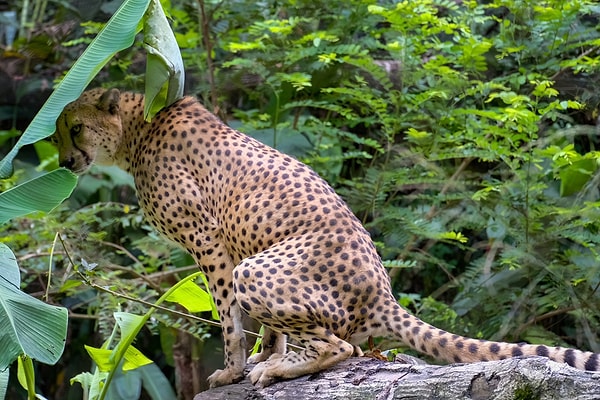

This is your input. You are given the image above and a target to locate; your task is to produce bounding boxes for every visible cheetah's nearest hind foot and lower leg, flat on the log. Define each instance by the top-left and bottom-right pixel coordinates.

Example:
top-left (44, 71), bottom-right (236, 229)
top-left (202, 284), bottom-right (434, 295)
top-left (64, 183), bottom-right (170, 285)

top-left (248, 327), bottom-right (354, 388)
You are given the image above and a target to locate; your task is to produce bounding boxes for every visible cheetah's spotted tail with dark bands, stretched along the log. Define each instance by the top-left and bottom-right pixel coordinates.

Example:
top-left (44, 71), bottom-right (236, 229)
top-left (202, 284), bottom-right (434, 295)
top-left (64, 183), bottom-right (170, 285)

top-left (383, 303), bottom-right (600, 371)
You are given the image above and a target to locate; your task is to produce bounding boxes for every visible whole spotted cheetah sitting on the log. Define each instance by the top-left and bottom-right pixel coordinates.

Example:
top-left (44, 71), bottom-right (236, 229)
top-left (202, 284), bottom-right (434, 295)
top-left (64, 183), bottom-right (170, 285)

top-left (55, 89), bottom-right (600, 387)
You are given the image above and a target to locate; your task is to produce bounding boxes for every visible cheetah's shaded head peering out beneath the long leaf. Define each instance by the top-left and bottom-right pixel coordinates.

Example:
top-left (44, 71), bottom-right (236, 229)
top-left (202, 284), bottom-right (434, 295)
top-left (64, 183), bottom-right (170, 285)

top-left (54, 89), bottom-right (122, 174)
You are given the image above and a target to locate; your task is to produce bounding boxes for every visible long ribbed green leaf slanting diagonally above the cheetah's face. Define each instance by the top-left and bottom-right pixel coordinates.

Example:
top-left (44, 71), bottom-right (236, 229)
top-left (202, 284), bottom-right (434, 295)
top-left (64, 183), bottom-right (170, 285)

top-left (0, 0), bottom-right (150, 178)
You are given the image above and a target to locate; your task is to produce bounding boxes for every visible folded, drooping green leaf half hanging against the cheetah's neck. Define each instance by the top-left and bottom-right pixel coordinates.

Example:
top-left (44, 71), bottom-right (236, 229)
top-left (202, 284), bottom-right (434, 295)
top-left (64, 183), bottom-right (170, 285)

top-left (144, 0), bottom-right (185, 121)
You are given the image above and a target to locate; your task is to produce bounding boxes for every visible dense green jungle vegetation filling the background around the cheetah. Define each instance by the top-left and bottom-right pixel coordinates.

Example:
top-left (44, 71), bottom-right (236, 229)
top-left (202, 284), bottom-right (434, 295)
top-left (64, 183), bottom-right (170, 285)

top-left (0, 0), bottom-right (600, 399)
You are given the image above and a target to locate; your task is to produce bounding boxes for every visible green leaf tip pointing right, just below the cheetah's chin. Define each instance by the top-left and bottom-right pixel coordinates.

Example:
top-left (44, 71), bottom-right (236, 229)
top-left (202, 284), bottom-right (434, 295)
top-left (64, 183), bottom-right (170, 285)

top-left (0, 168), bottom-right (77, 224)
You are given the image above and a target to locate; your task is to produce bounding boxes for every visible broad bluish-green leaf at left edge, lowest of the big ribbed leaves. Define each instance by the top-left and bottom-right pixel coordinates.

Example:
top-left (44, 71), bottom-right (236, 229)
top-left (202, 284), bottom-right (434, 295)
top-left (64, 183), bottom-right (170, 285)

top-left (0, 243), bottom-right (67, 371)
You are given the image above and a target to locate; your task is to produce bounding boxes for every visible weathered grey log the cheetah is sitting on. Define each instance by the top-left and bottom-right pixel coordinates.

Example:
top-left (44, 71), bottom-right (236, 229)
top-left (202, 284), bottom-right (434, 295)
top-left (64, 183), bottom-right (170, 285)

top-left (194, 357), bottom-right (600, 400)
